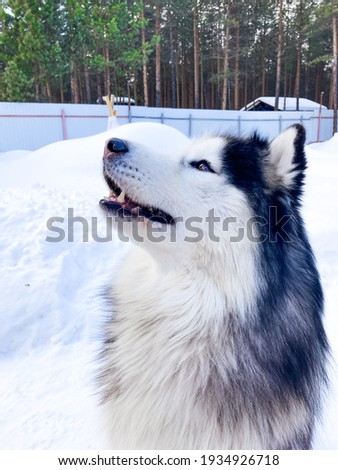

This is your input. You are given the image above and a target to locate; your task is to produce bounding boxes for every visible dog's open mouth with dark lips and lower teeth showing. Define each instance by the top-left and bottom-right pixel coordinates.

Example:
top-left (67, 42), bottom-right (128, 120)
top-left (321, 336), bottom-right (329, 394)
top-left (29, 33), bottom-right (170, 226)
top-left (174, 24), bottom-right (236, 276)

top-left (100, 173), bottom-right (175, 225)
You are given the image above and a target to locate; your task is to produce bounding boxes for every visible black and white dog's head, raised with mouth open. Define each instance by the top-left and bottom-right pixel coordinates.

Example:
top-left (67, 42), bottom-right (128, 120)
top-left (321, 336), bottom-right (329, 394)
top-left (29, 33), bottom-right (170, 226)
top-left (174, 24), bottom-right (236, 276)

top-left (100, 125), bottom-right (306, 264)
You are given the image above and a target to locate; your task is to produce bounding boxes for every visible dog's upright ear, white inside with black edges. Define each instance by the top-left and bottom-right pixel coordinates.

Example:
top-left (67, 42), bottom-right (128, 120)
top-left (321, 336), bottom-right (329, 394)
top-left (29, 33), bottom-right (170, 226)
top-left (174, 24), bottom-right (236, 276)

top-left (266, 124), bottom-right (306, 197)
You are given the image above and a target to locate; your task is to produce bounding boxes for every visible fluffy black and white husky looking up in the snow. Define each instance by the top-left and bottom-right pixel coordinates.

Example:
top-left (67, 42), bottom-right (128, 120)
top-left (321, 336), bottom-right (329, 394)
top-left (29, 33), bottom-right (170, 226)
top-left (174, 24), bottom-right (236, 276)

top-left (100, 125), bottom-right (328, 449)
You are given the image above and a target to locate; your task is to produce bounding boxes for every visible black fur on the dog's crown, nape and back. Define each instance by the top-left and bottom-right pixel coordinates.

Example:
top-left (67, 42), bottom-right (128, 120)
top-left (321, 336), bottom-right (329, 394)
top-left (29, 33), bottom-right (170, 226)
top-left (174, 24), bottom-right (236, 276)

top-left (219, 125), bottom-right (329, 449)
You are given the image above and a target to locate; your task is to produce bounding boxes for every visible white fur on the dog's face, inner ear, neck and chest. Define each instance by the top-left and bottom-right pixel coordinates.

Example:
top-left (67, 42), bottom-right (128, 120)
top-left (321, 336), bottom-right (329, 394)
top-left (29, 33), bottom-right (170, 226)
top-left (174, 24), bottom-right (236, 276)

top-left (98, 130), bottom-right (316, 449)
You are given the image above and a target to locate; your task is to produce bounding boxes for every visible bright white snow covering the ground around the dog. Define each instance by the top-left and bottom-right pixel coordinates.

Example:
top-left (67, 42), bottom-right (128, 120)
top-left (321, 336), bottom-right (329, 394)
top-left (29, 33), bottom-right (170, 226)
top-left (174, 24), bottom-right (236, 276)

top-left (0, 125), bottom-right (338, 449)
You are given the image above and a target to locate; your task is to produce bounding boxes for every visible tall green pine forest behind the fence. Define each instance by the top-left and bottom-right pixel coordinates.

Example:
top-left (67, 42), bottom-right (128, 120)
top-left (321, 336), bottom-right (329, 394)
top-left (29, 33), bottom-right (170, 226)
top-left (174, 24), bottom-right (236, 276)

top-left (0, 0), bottom-right (338, 114)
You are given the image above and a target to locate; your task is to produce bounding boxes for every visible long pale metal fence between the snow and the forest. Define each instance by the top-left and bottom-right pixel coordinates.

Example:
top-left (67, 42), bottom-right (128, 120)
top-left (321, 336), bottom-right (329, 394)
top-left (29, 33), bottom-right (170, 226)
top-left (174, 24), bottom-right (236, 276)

top-left (0, 103), bottom-right (333, 152)
